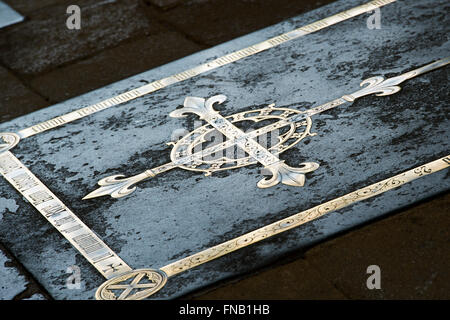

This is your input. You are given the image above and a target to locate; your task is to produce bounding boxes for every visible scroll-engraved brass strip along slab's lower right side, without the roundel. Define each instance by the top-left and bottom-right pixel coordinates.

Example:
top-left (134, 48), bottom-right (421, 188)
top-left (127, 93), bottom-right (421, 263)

top-left (160, 155), bottom-right (450, 277)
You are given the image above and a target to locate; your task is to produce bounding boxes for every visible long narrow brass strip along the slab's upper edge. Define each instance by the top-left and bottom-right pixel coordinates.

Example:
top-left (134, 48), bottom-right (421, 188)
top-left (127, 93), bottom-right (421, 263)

top-left (14, 0), bottom-right (397, 139)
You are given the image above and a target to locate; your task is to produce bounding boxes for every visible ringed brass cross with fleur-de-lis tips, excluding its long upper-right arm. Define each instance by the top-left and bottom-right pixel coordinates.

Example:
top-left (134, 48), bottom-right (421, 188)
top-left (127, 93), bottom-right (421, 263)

top-left (83, 95), bottom-right (319, 199)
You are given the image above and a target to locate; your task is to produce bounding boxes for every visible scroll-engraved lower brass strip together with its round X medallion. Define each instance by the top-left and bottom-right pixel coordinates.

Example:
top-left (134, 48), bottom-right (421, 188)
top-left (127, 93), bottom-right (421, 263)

top-left (95, 155), bottom-right (450, 300)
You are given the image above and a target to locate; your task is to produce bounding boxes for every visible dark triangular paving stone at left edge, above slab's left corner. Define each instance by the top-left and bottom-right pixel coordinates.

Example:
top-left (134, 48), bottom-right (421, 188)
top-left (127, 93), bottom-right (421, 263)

top-left (0, 67), bottom-right (48, 122)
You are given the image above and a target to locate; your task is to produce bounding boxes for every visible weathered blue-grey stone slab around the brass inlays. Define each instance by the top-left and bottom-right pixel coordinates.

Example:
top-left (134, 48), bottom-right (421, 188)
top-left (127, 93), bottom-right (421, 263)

top-left (0, 0), bottom-right (450, 299)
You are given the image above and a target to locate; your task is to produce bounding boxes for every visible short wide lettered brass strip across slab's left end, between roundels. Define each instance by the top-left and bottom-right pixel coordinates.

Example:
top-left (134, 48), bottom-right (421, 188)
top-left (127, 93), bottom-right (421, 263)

top-left (0, 151), bottom-right (132, 279)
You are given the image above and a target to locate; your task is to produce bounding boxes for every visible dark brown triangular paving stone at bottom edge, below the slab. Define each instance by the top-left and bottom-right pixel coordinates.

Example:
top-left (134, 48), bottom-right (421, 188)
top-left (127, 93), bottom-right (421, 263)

top-left (189, 259), bottom-right (345, 300)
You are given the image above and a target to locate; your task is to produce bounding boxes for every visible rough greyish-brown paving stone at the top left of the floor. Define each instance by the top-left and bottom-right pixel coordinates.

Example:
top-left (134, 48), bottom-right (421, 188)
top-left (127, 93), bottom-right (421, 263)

top-left (0, 0), bottom-right (162, 74)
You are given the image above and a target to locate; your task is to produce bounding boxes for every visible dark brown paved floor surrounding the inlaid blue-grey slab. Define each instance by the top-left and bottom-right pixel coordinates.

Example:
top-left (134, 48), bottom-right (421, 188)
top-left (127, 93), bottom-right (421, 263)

top-left (0, 0), bottom-right (450, 299)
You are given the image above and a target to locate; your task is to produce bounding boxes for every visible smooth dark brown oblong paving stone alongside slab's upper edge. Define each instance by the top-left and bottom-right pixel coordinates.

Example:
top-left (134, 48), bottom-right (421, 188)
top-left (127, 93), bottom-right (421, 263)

top-left (30, 31), bottom-right (201, 101)
